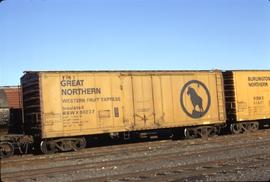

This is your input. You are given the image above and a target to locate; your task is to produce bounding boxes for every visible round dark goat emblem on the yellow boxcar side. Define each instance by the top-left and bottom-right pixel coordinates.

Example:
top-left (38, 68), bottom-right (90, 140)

top-left (180, 80), bottom-right (211, 118)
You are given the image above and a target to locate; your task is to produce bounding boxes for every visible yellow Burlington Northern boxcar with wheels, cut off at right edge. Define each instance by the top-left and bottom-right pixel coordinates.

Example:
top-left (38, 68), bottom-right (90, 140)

top-left (223, 70), bottom-right (270, 133)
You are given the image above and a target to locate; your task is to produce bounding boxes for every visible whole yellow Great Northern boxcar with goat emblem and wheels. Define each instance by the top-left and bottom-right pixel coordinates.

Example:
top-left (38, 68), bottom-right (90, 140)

top-left (21, 71), bottom-right (226, 153)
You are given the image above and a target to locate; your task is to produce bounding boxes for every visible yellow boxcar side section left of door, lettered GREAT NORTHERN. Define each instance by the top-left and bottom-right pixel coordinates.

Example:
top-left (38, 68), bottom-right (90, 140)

top-left (41, 72), bottom-right (124, 138)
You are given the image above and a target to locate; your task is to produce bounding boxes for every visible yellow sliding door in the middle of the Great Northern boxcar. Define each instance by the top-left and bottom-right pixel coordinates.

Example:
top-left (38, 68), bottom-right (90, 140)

top-left (121, 75), bottom-right (155, 129)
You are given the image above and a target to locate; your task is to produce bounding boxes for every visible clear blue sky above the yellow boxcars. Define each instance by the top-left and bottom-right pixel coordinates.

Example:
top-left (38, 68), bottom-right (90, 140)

top-left (0, 0), bottom-right (270, 86)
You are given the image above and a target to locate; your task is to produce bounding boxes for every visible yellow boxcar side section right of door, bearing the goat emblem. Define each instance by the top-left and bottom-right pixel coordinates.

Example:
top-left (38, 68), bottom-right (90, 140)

top-left (165, 73), bottom-right (225, 126)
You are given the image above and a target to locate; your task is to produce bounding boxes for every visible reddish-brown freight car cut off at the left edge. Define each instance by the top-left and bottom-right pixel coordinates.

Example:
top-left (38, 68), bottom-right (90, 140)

top-left (0, 86), bottom-right (31, 157)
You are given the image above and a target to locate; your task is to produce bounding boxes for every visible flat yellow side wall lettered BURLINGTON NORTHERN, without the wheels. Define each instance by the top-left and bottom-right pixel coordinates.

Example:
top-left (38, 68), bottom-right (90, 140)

top-left (233, 71), bottom-right (270, 121)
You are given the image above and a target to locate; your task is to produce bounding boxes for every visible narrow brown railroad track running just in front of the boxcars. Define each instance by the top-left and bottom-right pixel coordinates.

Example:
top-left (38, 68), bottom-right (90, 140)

top-left (1, 130), bottom-right (268, 166)
